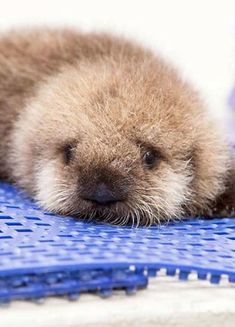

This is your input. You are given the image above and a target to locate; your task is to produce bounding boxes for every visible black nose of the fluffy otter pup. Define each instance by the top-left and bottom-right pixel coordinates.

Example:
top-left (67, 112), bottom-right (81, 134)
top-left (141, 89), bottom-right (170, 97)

top-left (84, 183), bottom-right (122, 204)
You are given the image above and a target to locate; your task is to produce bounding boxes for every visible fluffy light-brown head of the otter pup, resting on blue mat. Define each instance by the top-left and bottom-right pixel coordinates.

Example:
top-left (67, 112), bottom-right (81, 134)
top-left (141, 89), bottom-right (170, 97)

top-left (12, 61), bottom-right (228, 225)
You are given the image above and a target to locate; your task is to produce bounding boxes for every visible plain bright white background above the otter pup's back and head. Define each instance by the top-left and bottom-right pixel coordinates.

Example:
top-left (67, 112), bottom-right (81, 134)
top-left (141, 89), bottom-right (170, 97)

top-left (0, 0), bottom-right (235, 120)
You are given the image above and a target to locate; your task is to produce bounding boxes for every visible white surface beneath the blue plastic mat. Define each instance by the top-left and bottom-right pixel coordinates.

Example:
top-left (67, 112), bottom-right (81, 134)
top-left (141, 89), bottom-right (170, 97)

top-left (0, 276), bottom-right (235, 327)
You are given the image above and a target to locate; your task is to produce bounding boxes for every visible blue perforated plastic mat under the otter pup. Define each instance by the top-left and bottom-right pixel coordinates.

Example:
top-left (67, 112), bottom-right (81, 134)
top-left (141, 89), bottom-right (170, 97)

top-left (0, 184), bottom-right (235, 302)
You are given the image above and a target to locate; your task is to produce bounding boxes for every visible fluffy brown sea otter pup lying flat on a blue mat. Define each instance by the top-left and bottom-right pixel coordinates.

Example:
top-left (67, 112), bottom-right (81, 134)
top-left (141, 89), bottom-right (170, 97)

top-left (0, 29), bottom-right (235, 225)
